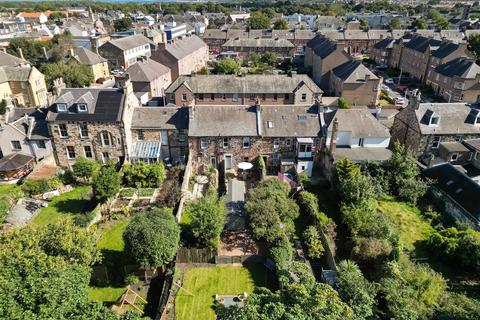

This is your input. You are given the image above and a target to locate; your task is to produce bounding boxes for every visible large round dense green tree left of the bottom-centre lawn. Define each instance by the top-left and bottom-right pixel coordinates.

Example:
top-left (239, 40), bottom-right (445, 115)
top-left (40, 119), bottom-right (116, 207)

top-left (123, 208), bottom-right (180, 268)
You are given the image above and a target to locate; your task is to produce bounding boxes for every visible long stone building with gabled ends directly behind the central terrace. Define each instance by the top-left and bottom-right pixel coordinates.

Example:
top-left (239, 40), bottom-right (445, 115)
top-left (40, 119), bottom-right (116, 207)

top-left (166, 74), bottom-right (323, 106)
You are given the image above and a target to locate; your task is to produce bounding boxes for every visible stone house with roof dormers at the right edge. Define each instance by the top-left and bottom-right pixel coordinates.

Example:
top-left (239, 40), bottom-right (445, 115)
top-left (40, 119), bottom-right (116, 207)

top-left (391, 92), bottom-right (480, 163)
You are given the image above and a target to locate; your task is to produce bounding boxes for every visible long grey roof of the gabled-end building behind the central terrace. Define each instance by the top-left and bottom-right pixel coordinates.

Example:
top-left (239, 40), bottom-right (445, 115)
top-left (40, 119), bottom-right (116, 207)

top-left (166, 74), bottom-right (323, 94)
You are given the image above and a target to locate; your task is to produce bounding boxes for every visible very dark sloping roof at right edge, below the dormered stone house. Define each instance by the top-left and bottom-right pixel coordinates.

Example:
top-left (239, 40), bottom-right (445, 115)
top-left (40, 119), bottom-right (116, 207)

top-left (423, 163), bottom-right (480, 222)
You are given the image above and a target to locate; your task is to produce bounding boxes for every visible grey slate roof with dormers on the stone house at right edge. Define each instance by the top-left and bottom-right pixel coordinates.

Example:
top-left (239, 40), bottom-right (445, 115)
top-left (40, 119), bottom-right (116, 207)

top-left (410, 103), bottom-right (480, 135)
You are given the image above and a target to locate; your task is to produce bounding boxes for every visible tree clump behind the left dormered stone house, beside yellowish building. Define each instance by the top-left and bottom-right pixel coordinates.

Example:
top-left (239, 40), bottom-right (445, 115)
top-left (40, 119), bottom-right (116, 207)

top-left (40, 61), bottom-right (94, 88)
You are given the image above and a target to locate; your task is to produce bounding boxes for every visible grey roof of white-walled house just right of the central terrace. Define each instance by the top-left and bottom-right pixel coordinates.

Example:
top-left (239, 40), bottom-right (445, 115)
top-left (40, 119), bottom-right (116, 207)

top-left (324, 109), bottom-right (390, 138)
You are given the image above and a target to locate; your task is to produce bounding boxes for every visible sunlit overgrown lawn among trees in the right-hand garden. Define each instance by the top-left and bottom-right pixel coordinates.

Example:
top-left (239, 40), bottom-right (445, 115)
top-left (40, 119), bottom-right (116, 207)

top-left (378, 198), bottom-right (434, 253)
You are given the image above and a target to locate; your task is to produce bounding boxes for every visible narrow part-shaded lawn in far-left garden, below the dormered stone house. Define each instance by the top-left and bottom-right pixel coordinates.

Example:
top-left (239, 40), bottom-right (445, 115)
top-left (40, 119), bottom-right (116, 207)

top-left (33, 186), bottom-right (96, 226)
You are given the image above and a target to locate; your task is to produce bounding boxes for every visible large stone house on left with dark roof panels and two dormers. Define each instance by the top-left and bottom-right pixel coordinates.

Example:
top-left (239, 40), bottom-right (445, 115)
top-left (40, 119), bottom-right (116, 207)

top-left (47, 79), bottom-right (139, 168)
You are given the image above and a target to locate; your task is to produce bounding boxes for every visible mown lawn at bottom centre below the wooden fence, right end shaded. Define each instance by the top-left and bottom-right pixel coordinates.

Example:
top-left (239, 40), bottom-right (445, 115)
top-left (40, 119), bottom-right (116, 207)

top-left (175, 264), bottom-right (273, 320)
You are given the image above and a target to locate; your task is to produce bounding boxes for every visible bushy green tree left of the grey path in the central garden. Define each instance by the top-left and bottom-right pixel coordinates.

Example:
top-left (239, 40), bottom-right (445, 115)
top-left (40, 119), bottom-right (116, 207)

top-left (185, 192), bottom-right (227, 248)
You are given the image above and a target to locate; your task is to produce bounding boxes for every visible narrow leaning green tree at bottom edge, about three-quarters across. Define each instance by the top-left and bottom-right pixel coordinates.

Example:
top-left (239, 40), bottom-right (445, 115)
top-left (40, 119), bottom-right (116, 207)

top-left (337, 260), bottom-right (377, 319)
